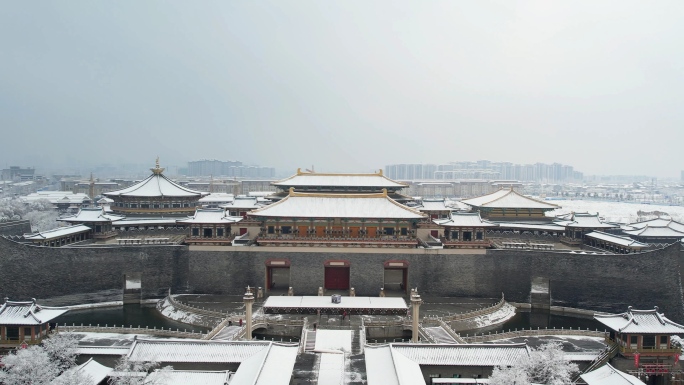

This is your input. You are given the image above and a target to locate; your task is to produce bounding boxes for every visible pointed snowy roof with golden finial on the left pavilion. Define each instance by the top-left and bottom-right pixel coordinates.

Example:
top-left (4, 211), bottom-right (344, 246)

top-left (103, 160), bottom-right (209, 198)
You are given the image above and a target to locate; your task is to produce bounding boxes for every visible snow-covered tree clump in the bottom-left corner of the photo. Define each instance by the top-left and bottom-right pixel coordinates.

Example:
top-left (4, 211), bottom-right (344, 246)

top-left (0, 346), bottom-right (59, 385)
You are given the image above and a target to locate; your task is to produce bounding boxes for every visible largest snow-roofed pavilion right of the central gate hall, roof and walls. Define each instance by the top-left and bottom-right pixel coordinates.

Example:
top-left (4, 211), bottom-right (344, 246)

top-left (461, 188), bottom-right (559, 221)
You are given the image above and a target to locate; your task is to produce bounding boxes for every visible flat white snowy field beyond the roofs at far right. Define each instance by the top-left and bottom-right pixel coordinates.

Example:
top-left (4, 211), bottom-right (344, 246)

top-left (546, 200), bottom-right (684, 223)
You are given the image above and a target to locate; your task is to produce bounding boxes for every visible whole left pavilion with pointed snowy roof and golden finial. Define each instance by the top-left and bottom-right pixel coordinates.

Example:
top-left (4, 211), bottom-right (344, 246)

top-left (104, 159), bottom-right (209, 216)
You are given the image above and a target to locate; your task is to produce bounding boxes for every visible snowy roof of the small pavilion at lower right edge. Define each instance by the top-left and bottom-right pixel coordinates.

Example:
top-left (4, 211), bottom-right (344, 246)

top-left (594, 306), bottom-right (684, 334)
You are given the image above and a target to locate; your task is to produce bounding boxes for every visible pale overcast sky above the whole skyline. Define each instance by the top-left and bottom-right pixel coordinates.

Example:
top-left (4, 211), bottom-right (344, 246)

top-left (0, 0), bottom-right (684, 177)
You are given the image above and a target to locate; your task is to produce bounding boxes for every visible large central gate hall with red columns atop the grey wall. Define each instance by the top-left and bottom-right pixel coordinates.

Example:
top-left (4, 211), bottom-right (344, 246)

top-left (247, 188), bottom-right (427, 247)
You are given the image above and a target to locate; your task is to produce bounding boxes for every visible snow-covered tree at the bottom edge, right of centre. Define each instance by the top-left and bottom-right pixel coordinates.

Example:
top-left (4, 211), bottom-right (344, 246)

top-left (491, 341), bottom-right (578, 385)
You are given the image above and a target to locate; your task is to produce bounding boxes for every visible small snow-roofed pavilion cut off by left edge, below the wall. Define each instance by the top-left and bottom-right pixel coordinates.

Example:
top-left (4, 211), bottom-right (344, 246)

top-left (0, 298), bottom-right (69, 347)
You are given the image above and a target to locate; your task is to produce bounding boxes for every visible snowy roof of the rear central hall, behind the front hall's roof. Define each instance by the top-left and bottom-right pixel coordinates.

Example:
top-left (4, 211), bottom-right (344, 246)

top-left (271, 169), bottom-right (408, 190)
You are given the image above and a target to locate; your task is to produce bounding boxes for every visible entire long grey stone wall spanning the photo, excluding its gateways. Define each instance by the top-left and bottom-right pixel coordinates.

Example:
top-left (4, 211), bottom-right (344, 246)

top-left (0, 238), bottom-right (684, 322)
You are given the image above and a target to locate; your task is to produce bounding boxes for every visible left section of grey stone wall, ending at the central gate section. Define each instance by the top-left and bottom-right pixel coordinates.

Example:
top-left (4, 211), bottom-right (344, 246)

top-left (0, 238), bottom-right (188, 300)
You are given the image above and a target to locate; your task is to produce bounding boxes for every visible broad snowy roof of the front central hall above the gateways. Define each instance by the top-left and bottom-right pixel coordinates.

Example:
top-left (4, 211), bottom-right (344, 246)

top-left (248, 188), bottom-right (427, 219)
